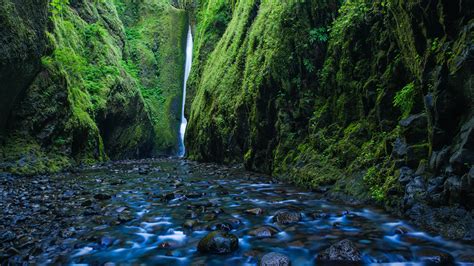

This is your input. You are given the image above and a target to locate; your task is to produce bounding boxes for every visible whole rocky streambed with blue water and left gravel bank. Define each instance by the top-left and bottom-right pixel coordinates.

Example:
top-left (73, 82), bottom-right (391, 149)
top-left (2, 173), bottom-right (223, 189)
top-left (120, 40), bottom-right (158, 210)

top-left (0, 159), bottom-right (474, 265)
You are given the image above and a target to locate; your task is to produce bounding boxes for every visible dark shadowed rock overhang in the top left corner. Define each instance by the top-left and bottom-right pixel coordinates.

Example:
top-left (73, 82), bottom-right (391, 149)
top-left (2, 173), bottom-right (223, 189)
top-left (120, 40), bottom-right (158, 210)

top-left (0, 0), bottom-right (48, 134)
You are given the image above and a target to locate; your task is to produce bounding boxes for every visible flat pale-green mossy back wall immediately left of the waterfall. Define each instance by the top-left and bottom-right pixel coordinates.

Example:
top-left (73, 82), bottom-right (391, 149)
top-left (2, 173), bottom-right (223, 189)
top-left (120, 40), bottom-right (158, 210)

top-left (116, 0), bottom-right (187, 152)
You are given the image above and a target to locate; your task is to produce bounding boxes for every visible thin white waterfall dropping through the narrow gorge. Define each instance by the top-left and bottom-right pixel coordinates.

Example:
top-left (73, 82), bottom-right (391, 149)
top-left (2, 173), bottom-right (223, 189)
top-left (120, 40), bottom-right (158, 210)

top-left (178, 25), bottom-right (193, 157)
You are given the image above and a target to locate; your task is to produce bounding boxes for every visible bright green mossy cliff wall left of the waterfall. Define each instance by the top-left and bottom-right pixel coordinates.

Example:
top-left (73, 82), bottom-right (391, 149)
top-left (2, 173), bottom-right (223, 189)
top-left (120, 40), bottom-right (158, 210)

top-left (0, 0), bottom-right (186, 174)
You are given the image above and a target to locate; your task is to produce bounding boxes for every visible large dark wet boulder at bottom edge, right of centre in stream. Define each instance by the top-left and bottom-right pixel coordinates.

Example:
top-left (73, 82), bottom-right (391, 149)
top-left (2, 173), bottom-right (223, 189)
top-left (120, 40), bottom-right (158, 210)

top-left (316, 239), bottom-right (362, 262)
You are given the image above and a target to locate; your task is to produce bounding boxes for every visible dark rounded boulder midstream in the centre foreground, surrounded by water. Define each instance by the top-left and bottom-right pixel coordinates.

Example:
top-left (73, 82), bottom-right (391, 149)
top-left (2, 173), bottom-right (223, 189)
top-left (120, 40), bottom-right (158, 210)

top-left (198, 231), bottom-right (239, 254)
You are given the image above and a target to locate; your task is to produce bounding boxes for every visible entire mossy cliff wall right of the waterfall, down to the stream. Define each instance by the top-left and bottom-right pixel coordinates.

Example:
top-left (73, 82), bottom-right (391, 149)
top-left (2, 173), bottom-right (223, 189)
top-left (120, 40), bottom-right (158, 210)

top-left (187, 0), bottom-right (474, 238)
